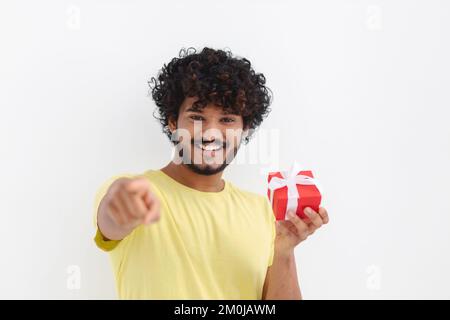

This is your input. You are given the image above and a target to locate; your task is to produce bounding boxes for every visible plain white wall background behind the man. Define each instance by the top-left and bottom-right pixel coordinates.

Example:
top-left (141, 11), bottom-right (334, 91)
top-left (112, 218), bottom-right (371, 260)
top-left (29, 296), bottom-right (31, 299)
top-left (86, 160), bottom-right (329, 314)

top-left (0, 0), bottom-right (450, 299)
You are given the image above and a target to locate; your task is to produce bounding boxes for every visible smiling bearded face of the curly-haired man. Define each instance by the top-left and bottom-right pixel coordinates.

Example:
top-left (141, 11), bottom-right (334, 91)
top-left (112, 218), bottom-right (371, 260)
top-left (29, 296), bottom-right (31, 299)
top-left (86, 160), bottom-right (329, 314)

top-left (169, 97), bottom-right (244, 175)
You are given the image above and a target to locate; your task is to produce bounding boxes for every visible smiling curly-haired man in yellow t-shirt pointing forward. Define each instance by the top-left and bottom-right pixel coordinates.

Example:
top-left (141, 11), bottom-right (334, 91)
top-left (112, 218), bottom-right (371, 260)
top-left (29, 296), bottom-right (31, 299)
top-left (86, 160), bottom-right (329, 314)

top-left (94, 48), bottom-right (328, 299)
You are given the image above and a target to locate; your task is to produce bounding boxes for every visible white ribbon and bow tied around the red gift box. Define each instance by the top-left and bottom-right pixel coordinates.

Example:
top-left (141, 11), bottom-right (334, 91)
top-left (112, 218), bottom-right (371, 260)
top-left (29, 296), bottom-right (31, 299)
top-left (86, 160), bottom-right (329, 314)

top-left (269, 162), bottom-right (322, 218)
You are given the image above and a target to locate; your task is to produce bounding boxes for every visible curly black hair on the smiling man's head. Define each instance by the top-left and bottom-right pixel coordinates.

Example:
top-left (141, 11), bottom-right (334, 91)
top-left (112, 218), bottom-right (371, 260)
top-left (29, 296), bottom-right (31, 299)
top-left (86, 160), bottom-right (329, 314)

top-left (148, 47), bottom-right (273, 143)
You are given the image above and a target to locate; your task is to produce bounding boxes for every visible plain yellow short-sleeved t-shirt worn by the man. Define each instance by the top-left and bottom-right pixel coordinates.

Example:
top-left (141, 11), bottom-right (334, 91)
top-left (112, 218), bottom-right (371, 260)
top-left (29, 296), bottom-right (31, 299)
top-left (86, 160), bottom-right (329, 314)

top-left (94, 170), bottom-right (275, 299)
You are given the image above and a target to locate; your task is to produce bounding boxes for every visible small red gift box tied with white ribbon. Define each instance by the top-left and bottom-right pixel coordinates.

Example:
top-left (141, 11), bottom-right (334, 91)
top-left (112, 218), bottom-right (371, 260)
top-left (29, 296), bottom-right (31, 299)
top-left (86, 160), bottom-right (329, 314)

top-left (267, 164), bottom-right (322, 220)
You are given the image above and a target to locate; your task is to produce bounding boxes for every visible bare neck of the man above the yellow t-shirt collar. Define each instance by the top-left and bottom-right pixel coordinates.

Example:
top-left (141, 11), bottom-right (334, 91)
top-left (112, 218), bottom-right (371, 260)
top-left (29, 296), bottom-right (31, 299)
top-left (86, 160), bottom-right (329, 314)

top-left (161, 161), bottom-right (225, 192)
